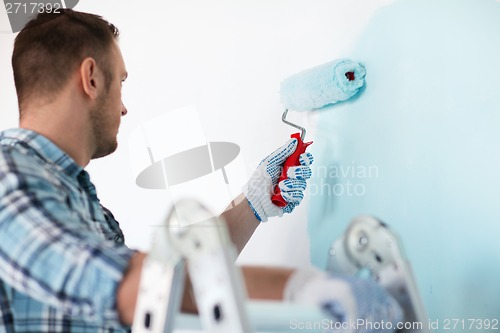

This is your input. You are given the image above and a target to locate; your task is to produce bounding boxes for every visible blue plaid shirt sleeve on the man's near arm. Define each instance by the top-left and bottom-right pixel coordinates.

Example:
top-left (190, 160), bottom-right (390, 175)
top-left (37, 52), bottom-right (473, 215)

top-left (0, 169), bottom-right (134, 326)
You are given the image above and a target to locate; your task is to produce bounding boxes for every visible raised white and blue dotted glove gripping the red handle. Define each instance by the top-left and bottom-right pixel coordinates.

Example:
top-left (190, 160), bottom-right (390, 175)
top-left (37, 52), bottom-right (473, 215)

top-left (243, 139), bottom-right (313, 222)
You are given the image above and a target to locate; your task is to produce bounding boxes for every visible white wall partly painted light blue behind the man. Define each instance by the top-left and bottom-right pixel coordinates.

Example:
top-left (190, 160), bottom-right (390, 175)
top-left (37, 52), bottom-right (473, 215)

top-left (0, 0), bottom-right (500, 326)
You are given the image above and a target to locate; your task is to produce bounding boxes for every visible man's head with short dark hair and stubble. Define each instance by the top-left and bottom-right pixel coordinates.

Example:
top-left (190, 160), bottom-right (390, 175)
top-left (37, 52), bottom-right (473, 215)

top-left (12, 9), bottom-right (127, 158)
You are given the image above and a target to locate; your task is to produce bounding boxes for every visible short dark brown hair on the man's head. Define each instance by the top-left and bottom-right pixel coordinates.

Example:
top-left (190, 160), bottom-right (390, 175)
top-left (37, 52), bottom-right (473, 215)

top-left (12, 9), bottom-right (119, 110)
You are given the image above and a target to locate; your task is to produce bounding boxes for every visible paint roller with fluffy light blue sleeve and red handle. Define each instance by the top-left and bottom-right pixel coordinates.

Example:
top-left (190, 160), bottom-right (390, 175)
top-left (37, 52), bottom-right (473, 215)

top-left (271, 59), bottom-right (366, 207)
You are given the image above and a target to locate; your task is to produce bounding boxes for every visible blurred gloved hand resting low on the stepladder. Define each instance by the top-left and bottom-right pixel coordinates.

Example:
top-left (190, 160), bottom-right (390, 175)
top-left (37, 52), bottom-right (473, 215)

top-left (283, 268), bottom-right (403, 332)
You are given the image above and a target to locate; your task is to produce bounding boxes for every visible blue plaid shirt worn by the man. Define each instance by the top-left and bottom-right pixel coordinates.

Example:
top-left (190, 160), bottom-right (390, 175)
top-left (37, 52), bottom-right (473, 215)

top-left (0, 129), bottom-right (133, 333)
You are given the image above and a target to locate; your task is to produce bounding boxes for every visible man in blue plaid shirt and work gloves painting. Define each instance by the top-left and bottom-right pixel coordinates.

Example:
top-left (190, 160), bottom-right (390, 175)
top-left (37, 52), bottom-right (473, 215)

top-left (0, 10), bottom-right (400, 332)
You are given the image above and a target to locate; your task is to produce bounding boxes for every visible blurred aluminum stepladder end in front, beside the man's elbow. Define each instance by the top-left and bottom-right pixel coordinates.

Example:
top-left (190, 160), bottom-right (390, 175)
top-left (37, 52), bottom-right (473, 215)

top-left (132, 200), bottom-right (252, 333)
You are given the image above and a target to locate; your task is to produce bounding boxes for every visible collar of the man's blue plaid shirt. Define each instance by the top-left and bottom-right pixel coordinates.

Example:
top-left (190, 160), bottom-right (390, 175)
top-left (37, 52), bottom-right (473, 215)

top-left (0, 128), bottom-right (83, 178)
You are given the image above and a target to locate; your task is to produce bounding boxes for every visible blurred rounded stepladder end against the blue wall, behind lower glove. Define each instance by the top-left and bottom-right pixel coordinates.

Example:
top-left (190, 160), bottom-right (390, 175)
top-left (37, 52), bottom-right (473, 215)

top-left (328, 215), bottom-right (431, 333)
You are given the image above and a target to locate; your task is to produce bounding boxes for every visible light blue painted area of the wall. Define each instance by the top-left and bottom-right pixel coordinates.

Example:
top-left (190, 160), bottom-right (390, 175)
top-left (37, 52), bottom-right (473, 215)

top-left (309, 0), bottom-right (500, 322)
